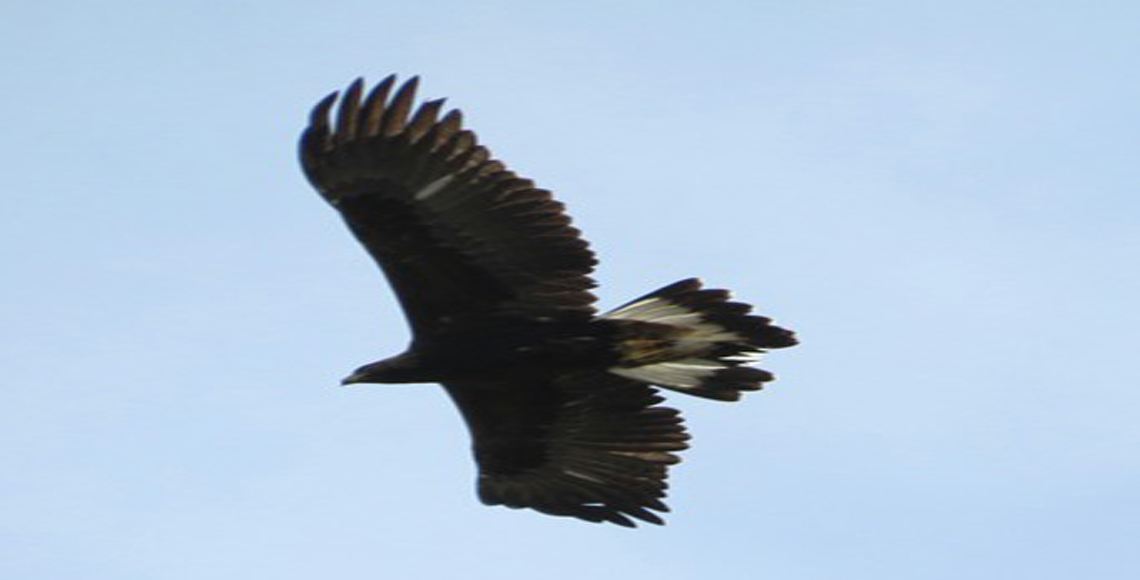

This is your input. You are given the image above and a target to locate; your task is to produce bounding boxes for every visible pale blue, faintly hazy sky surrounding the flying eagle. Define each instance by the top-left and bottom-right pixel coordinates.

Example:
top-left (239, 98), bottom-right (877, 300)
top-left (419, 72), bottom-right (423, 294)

top-left (0, 0), bottom-right (1140, 580)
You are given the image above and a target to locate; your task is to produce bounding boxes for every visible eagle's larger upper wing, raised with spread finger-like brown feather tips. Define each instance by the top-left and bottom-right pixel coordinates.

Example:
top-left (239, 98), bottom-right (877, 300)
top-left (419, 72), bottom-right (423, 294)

top-left (301, 76), bottom-right (595, 334)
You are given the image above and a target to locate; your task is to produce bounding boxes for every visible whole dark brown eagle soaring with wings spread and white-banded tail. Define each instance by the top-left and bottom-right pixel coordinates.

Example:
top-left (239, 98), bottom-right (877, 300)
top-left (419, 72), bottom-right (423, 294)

top-left (300, 75), bottom-right (796, 528)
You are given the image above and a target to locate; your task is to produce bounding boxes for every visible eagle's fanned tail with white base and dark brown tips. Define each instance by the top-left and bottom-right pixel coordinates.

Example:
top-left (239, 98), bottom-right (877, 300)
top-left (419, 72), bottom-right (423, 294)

top-left (603, 278), bottom-right (796, 401)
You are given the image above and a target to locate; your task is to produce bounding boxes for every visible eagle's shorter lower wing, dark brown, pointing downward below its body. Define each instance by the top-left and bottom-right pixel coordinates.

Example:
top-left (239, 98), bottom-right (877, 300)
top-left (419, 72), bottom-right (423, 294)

top-left (443, 371), bottom-right (689, 526)
